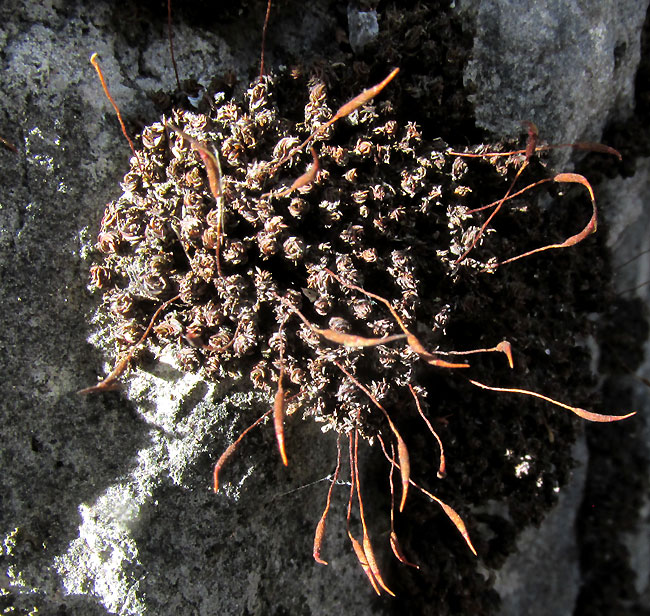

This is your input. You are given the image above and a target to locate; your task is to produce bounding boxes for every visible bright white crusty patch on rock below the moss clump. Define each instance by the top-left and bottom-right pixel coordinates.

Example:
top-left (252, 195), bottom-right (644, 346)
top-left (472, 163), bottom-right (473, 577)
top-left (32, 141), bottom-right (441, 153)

top-left (52, 360), bottom-right (270, 614)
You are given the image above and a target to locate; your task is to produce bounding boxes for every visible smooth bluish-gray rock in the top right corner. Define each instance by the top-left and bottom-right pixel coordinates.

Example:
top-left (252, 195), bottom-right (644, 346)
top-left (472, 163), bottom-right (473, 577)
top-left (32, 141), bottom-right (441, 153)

top-left (458, 0), bottom-right (648, 160)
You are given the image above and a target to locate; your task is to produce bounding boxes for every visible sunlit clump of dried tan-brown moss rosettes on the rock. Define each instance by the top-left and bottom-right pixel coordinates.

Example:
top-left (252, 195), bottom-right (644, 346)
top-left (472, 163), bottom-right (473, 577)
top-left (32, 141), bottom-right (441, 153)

top-left (88, 71), bottom-right (515, 436)
